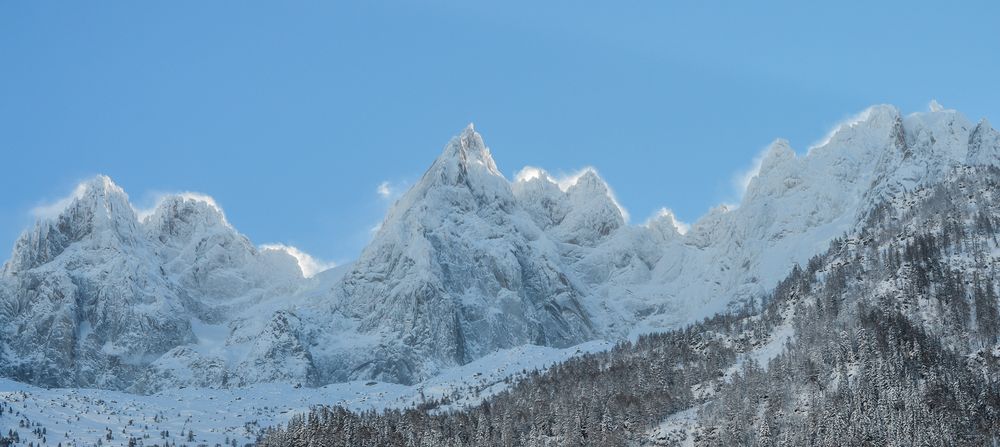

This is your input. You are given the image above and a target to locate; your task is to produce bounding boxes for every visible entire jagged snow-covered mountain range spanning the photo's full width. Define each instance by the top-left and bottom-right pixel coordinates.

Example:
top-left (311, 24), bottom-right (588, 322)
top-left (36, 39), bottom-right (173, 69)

top-left (0, 102), bottom-right (1000, 392)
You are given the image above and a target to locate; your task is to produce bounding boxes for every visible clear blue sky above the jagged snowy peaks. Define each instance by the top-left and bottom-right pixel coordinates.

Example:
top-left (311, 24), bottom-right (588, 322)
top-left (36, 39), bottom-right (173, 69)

top-left (0, 1), bottom-right (1000, 261)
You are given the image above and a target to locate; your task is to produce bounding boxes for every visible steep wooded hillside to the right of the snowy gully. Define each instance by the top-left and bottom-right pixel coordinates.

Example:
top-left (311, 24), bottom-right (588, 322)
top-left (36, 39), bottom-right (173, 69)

top-left (696, 169), bottom-right (1000, 446)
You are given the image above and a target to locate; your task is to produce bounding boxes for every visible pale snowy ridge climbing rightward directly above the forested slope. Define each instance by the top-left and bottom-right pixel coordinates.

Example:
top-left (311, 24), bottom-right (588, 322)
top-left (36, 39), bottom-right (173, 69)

top-left (573, 106), bottom-right (1000, 333)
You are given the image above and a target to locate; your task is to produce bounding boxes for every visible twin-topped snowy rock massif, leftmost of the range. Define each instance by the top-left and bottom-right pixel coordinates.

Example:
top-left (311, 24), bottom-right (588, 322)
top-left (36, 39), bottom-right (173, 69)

top-left (0, 180), bottom-right (302, 389)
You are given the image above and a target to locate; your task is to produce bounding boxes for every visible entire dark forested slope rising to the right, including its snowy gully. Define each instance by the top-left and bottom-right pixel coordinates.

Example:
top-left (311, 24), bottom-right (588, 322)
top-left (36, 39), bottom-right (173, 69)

top-left (259, 166), bottom-right (1000, 446)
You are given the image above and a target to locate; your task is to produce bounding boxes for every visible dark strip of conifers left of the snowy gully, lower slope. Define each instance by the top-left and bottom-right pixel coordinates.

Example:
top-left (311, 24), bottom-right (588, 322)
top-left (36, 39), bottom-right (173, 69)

top-left (260, 298), bottom-right (796, 446)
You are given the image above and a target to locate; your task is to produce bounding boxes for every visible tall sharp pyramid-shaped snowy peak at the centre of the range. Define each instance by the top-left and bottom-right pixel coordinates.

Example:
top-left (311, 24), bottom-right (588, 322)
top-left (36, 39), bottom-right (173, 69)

top-left (335, 126), bottom-right (597, 381)
